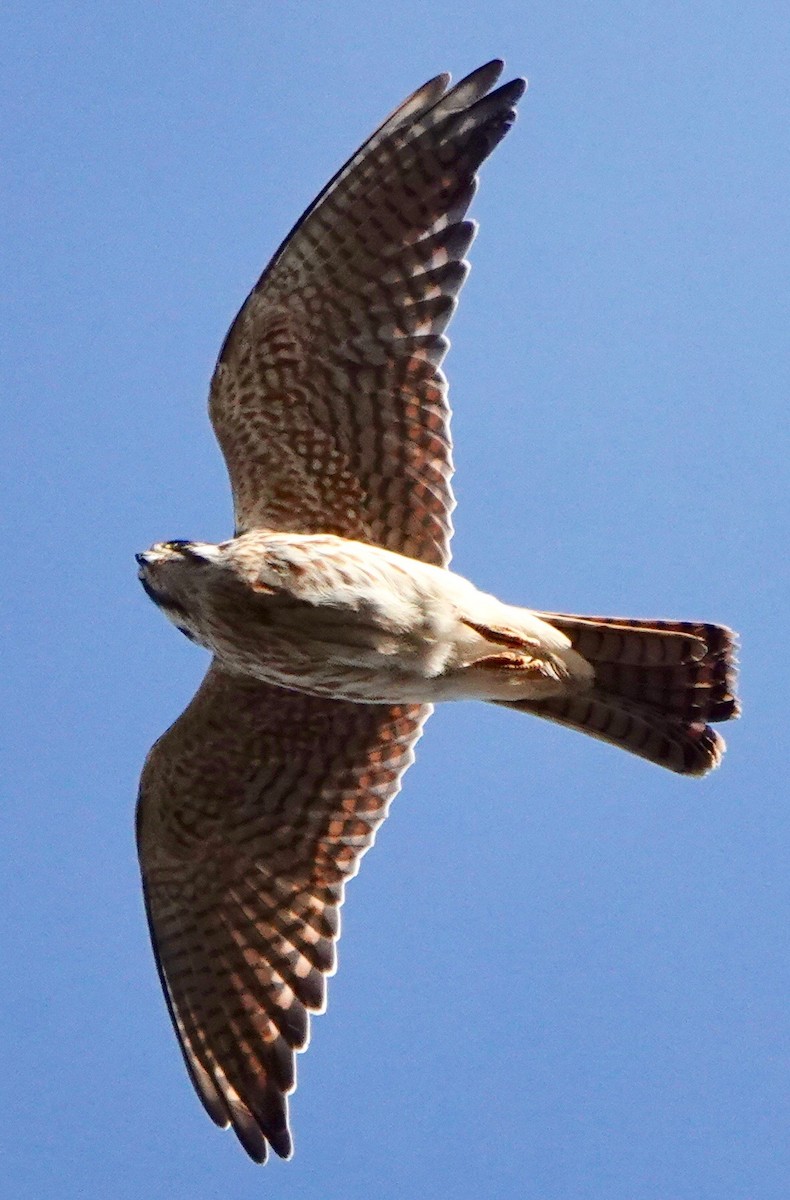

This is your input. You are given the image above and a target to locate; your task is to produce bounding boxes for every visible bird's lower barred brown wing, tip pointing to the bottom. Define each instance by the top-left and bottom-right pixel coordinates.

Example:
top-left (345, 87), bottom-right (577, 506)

top-left (137, 664), bottom-right (430, 1162)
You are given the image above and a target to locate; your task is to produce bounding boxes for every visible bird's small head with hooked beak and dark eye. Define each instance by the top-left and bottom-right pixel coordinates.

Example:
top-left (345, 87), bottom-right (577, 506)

top-left (134, 540), bottom-right (222, 642)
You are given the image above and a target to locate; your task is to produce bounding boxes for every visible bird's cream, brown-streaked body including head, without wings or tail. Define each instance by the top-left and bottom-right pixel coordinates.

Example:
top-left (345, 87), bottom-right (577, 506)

top-left (140, 529), bottom-right (593, 704)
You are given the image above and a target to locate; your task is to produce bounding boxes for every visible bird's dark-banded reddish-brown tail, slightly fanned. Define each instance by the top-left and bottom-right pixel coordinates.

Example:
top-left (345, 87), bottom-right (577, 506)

top-left (496, 612), bottom-right (740, 775)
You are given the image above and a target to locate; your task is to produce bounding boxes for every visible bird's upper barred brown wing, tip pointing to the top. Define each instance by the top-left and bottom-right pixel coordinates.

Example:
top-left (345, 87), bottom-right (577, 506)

top-left (210, 61), bottom-right (526, 565)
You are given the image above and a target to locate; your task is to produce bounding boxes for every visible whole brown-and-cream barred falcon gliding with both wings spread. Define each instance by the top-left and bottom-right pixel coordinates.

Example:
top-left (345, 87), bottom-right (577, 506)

top-left (137, 61), bottom-right (737, 1162)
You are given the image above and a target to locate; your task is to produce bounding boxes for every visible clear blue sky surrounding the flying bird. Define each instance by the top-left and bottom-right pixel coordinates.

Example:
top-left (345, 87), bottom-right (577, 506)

top-left (0, 0), bottom-right (790, 1200)
